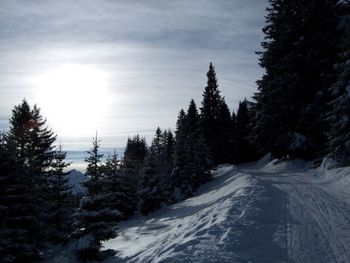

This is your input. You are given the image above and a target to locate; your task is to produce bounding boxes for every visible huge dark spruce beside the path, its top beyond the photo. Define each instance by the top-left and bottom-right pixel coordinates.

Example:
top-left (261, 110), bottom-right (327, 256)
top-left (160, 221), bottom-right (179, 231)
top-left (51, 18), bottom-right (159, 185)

top-left (255, 0), bottom-right (340, 158)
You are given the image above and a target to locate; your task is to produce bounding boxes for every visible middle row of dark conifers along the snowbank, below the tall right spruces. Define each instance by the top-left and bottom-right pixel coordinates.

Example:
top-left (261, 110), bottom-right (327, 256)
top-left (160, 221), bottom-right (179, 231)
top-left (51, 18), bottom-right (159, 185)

top-left (74, 64), bottom-right (256, 259)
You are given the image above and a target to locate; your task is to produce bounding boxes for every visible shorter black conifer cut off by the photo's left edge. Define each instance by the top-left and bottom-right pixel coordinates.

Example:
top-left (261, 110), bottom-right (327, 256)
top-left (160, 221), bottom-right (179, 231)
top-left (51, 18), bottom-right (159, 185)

top-left (0, 136), bottom-right (39, 263)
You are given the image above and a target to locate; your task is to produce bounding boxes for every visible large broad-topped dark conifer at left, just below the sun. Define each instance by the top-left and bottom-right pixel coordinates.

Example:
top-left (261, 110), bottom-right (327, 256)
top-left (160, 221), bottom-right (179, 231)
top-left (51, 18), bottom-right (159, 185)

top-left (1, 100), bottom-right (56, 262)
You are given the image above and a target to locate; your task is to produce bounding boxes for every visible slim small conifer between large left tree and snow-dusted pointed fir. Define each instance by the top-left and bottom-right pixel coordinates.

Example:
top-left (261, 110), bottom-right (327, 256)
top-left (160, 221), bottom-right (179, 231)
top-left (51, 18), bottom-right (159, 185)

top-left (47, 145), bottom-right (76, 242)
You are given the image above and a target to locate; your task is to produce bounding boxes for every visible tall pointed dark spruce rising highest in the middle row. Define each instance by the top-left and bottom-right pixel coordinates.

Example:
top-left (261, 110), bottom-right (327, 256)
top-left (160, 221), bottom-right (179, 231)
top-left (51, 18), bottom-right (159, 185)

top-left (201, 63), bottom-right (231, 164)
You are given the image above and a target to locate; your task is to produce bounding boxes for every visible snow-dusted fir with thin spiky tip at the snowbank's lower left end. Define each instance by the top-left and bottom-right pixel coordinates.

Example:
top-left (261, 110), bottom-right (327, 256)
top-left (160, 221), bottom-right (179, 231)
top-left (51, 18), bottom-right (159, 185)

top-left (75, 134), bottom-right (120, 260)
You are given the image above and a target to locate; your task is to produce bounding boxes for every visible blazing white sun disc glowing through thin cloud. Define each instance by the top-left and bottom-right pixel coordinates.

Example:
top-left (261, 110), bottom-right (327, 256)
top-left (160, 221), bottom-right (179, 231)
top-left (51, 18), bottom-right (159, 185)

top-left (34, 64), bottom-right (109, 136)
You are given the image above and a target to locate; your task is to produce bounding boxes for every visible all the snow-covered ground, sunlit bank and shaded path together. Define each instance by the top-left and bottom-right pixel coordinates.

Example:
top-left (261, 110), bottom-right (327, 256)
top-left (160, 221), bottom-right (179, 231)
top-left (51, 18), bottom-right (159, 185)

top-left (104, 158), bottom-right (350, 263)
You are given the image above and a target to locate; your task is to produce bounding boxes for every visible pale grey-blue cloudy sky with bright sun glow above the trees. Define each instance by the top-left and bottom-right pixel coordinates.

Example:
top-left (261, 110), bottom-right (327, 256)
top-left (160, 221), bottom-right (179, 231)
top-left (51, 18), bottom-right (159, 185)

top-left (0, 0), bottom-right (267, 149)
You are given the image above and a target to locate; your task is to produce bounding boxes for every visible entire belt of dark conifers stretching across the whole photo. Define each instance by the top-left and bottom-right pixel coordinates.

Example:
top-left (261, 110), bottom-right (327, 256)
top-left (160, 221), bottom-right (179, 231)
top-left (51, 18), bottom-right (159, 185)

top-left (0, 0), bottom-right (350, 262)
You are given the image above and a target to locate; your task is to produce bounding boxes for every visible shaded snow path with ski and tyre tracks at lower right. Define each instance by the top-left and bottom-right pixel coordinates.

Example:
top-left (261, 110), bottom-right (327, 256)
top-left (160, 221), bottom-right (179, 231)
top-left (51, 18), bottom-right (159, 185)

top-left (253, 169), bottom-right (350, 263)
